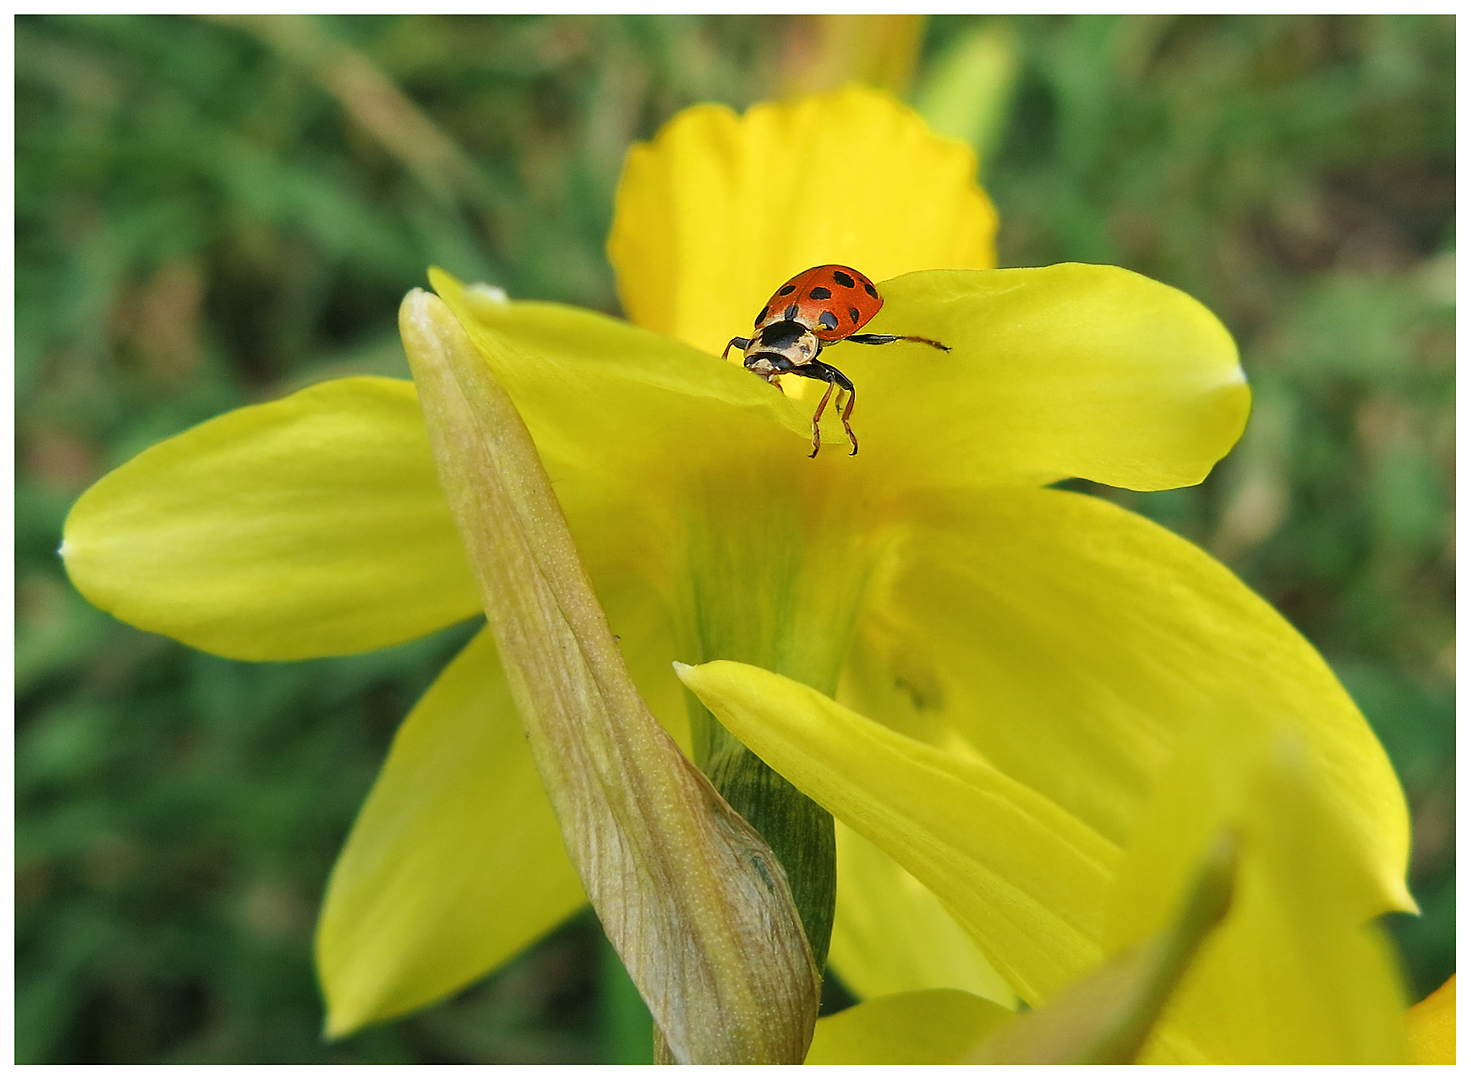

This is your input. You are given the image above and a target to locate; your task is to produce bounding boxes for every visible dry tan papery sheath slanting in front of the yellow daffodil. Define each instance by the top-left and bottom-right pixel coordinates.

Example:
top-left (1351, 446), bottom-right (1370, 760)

top-left (400, 290), bottom-right (821, 1064)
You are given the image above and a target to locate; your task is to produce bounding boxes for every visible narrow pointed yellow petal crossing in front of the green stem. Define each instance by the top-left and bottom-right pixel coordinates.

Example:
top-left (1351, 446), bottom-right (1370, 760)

top-left (678, 661), bottom-right (1118, 1002)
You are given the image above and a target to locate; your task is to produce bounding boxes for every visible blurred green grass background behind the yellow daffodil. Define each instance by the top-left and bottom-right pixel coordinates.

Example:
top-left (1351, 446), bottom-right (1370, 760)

top-left (15, 16), bottom-right (1455, 1062)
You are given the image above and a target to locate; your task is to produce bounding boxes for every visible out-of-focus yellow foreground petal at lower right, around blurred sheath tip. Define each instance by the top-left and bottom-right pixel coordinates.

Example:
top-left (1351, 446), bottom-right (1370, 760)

top-left (1106, 724), bottom-right (1406, 1064)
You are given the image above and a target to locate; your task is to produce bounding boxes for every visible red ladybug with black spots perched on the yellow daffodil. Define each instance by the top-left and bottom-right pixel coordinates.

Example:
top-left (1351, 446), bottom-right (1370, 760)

top-left (721, 263), bottom-right (950, 458)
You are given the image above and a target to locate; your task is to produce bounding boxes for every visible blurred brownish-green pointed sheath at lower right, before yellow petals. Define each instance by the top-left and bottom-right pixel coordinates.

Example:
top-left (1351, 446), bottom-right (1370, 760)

top-left (971, 833), bottom-right (1239, 1065)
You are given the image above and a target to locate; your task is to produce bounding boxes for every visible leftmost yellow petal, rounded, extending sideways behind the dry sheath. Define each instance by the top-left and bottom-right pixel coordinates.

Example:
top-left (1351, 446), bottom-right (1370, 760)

top-left (62, 378), bottom-right (480, 661)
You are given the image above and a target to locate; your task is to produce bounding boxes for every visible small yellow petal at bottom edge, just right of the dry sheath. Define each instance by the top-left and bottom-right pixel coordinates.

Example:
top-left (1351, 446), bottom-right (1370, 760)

top-left (806, 990), bottom-right (1012, 1065)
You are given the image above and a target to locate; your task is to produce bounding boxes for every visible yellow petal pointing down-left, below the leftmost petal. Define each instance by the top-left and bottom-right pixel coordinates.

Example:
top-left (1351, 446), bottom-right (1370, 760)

top-left (316, 630), bottom-right (585, 1036)
